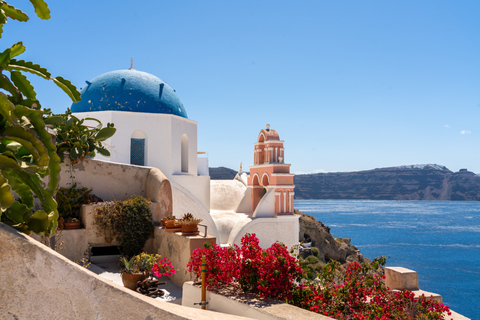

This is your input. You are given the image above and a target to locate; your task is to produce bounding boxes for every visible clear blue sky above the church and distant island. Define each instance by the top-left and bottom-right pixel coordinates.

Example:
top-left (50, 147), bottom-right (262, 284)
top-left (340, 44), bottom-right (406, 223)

top-left (1, 0), bottom-right (480, 173)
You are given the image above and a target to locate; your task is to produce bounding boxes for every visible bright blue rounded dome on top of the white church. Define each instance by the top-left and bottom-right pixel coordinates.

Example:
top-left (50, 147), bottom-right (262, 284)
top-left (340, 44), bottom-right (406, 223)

top-left (71, 69), bottom-right (188, 118)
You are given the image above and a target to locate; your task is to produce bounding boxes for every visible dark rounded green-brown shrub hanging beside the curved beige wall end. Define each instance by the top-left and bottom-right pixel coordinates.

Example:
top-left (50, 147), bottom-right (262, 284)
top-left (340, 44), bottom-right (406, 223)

top-left (94, 196), bottom-right (153, 257)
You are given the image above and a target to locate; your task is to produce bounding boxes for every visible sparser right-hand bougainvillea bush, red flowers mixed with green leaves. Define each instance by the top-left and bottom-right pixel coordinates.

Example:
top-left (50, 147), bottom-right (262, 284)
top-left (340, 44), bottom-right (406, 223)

top-left (288, 257), bottom-right (450, 319)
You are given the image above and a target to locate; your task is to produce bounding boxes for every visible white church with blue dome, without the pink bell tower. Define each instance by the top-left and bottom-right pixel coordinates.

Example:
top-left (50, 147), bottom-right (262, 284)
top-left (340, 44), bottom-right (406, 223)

top-left (71, 68), bottom-right (210, 225)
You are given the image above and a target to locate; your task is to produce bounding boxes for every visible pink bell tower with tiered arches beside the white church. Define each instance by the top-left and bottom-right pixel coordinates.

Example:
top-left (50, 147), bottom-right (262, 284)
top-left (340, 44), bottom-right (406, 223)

top-left (248, 124), bottom-right (295, 215)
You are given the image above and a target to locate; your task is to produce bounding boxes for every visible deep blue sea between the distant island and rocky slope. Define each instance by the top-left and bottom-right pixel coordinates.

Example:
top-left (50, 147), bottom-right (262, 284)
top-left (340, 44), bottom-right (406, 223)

top-left (295, 200), bottom-right (480, 319)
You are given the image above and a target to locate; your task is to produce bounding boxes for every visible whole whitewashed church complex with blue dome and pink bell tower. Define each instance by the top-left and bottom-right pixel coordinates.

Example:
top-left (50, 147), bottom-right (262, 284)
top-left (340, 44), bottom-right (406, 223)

top-left (71, 68), bottom-right (299, 247)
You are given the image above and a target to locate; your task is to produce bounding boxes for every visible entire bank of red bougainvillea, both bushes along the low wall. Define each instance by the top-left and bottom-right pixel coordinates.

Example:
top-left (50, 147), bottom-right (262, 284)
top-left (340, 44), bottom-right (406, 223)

top-left (187, 234), bottom-right (450, 320)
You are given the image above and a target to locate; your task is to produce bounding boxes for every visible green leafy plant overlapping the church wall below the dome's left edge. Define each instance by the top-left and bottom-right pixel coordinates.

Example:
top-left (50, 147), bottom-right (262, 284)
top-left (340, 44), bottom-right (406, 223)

top-left (45, 108), bottom-right (116, 164)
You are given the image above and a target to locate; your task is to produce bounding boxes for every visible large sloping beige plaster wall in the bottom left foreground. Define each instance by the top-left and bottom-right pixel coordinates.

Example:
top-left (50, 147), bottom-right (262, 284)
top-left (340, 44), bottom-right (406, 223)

top-left (0, 223), bottom-right (245, 320)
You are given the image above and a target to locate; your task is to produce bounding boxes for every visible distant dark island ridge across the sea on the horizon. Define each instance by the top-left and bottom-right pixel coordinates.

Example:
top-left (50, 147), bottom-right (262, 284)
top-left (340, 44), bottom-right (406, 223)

top-left (210, 164), bottom-right (480, 201)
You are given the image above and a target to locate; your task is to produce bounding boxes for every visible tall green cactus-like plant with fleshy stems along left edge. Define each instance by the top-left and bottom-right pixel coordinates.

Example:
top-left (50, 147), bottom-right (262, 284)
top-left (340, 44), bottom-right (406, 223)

top-left (0, 0), bottom-right (80, 236)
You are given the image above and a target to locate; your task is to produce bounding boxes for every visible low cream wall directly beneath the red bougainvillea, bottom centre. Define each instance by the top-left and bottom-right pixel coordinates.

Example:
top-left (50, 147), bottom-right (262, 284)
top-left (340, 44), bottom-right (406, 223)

top-left (182, 281), bottom-right (332, 320)
